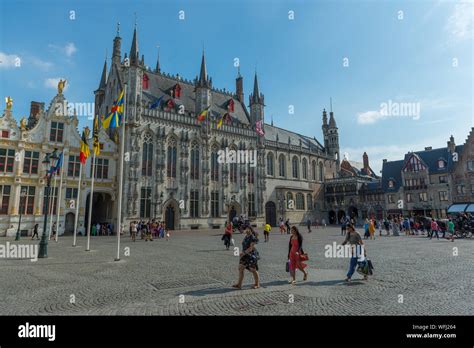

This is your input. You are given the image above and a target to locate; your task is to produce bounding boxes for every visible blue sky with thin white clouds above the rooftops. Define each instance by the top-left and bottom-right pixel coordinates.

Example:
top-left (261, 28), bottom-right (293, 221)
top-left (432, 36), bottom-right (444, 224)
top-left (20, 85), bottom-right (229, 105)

top-left (0, 0), bottom-right (474, 171)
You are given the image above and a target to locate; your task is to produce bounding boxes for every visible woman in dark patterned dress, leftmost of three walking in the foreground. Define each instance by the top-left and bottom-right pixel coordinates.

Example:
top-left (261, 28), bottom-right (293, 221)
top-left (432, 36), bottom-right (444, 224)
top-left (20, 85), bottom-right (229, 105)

top-left (232, 228), bottom-right (260, 289)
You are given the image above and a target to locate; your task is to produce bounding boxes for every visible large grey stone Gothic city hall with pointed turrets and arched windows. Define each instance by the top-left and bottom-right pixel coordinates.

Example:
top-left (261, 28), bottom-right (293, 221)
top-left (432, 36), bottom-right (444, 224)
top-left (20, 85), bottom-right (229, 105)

top-left (95, 26), bottom-right (339, 229)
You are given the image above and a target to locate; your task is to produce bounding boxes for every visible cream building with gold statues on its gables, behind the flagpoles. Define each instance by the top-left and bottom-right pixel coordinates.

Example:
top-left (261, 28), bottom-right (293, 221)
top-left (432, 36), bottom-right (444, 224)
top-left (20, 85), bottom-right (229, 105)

top-left (0, 90), bottom-right (117, 236)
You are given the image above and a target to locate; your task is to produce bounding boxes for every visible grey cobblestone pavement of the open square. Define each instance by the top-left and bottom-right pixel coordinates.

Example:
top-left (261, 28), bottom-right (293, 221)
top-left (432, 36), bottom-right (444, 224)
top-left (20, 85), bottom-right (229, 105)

top-left (0, 227), bottom-right (474, 315)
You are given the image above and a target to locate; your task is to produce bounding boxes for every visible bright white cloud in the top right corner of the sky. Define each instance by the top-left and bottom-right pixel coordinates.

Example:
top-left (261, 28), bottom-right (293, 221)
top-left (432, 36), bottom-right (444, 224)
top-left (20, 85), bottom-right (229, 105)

top-left (445, 0), bottom-right (474, 41)
